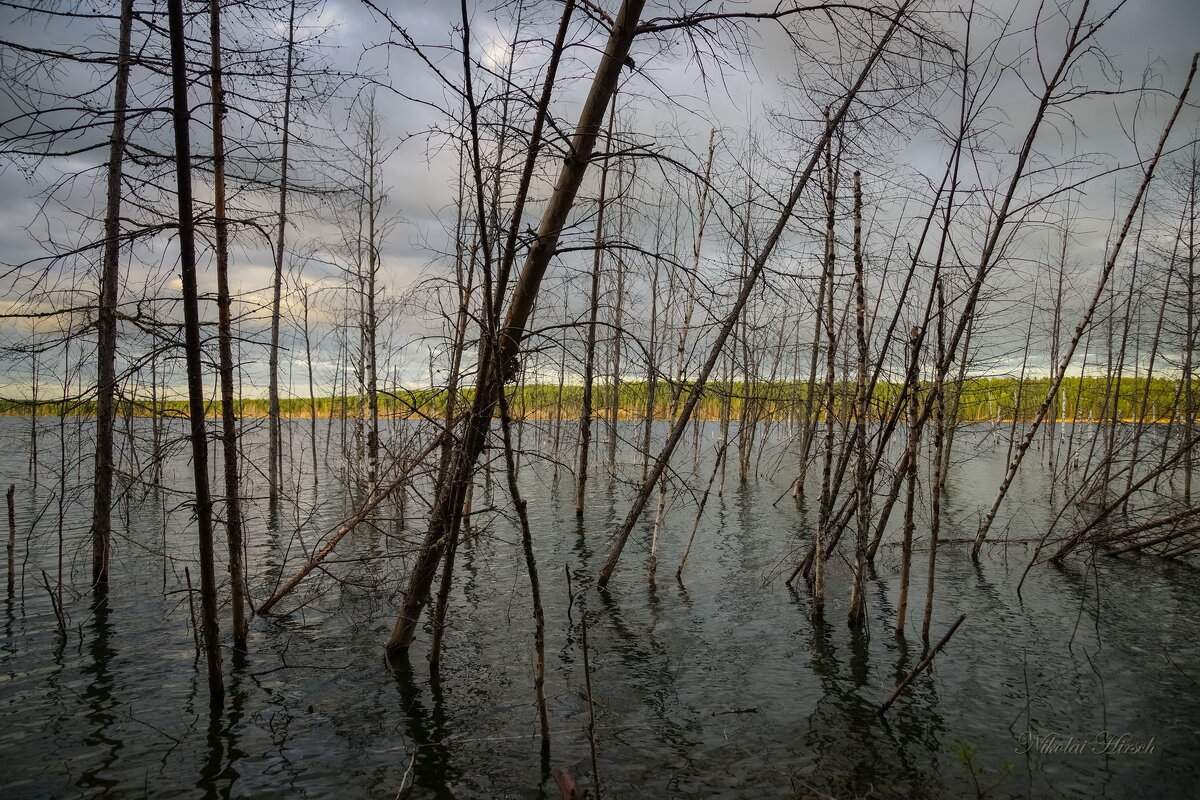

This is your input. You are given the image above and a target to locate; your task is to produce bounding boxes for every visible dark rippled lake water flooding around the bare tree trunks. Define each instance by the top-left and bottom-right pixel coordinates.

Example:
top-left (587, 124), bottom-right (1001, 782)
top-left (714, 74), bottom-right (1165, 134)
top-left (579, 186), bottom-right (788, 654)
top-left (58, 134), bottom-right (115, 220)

top-left (0, 417), bottom-right (1200, 799)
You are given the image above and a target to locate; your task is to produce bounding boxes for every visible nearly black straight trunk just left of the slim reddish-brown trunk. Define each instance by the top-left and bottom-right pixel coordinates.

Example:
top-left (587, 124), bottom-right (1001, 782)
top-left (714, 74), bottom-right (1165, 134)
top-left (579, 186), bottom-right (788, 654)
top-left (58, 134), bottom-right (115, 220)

top-left (167, 0), bottom-right (224, 708)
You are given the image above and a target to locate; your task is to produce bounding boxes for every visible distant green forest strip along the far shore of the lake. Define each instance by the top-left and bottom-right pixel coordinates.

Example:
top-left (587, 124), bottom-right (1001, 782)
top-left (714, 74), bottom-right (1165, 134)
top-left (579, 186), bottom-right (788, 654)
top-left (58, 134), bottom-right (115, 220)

top-left (0, 377), bottom-right (1200, 422)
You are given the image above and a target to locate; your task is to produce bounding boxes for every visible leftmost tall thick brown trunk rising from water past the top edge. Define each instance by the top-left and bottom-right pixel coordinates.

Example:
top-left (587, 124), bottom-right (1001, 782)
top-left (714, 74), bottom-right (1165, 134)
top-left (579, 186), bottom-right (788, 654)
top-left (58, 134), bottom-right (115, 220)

top-left (88, 0), bottom-right (133, 593)
